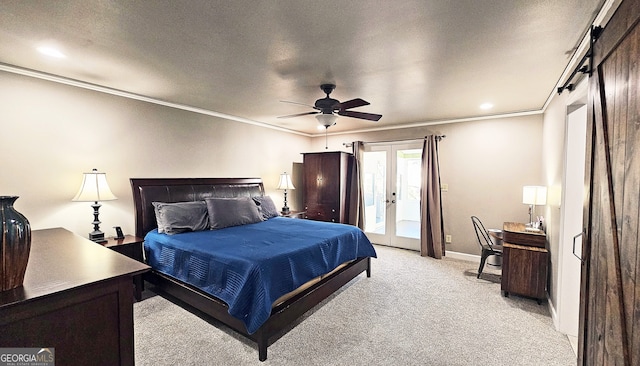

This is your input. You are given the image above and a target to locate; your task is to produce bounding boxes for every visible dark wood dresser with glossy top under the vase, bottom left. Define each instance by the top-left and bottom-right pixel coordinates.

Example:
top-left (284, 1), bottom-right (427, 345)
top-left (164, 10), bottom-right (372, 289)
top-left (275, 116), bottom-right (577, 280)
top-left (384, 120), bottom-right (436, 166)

top-left (0, 228), bottom-right (149, 365)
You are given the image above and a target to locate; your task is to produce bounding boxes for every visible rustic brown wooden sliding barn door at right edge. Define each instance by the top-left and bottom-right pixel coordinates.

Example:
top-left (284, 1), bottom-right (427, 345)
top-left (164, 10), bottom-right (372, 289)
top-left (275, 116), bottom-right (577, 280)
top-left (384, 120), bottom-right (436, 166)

top-left (578, 0), bottom-right (640, 366)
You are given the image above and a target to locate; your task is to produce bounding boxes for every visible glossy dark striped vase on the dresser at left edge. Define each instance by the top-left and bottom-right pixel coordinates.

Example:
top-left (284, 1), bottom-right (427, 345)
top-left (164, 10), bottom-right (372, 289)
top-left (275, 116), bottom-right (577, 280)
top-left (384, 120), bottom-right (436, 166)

top-left (0, 196), bottom-right (31, 291)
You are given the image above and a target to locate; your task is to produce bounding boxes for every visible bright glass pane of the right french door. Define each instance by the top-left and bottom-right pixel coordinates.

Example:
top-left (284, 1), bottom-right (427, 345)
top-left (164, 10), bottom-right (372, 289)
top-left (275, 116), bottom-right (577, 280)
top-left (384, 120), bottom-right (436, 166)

top-left (395, 149), bottom-right (422, 239)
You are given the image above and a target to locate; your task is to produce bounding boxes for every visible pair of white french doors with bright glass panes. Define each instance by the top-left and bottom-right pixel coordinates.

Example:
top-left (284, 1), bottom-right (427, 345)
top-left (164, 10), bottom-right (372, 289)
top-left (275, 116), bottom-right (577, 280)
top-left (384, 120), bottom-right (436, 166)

top-left (361, 143), bottom-right (422, 250)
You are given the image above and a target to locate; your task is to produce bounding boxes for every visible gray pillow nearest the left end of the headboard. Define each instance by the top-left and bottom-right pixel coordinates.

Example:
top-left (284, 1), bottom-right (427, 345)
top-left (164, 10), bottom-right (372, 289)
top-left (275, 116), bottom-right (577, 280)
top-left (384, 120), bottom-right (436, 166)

top-left (152, 201), bottom-right (209, 235)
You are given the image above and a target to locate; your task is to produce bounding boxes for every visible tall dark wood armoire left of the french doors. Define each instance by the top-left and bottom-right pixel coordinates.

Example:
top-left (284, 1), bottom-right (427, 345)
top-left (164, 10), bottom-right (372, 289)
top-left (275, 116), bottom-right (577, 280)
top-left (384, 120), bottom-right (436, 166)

top-left (302, 151), bottom-right (353, 223)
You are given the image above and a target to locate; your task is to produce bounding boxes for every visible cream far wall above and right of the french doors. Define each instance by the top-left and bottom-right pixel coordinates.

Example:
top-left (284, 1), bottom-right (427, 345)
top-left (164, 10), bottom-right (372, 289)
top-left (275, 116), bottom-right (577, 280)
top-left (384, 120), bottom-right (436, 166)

top-left (312, 114), bottom-right (544, 255)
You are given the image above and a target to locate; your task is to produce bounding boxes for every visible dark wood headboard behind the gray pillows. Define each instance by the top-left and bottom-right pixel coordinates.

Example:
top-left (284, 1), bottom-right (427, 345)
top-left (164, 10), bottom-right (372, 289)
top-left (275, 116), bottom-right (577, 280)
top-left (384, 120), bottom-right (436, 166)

top-left (130, 178), bottom-right (264, 238)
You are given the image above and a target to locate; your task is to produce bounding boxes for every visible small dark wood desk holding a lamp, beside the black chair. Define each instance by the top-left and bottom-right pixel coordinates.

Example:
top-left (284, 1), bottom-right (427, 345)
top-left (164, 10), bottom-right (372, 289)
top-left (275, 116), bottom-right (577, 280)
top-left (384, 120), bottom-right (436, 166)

top-left (501, 222), bottom-right (549, 304)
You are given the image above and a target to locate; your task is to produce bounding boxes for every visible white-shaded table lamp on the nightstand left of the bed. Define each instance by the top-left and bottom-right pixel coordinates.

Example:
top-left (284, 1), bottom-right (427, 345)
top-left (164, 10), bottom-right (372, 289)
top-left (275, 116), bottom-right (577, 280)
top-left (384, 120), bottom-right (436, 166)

top-left (72, 169), bottom-right (118, 243)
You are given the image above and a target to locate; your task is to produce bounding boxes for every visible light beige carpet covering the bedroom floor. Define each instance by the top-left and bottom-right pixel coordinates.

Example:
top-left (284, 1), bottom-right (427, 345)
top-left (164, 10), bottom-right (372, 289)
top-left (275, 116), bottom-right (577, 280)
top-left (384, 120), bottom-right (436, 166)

top-left (134, 246), bottom-right (576, 365)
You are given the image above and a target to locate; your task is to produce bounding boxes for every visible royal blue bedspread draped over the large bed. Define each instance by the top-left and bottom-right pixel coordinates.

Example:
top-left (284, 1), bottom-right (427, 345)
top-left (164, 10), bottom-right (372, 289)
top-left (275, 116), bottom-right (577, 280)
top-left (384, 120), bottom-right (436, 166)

top-left (144, 217), bottom-right (376, 333)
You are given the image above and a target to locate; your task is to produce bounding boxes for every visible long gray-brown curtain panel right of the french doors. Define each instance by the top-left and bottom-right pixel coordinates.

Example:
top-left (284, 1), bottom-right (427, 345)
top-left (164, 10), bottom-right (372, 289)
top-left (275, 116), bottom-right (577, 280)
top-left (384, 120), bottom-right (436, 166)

top-left (420, 135), bottom-right (445, 259)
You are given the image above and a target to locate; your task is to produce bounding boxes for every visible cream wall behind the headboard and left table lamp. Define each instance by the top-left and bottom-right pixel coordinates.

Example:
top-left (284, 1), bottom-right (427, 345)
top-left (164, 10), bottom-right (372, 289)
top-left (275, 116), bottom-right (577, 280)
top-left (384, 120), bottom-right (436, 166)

top-left (0, 72), bottom-right (310, 236)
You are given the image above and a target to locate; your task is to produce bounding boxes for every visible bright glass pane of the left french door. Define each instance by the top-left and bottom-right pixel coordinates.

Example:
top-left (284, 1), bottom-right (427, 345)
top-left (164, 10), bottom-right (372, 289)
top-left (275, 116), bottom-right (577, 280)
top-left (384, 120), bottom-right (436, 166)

top-left (362, 151), bottom-right (387, 234)
